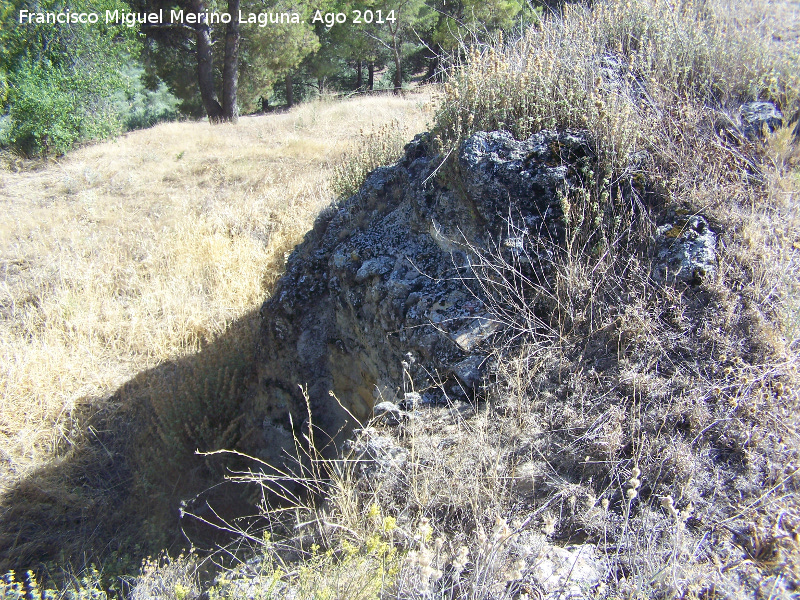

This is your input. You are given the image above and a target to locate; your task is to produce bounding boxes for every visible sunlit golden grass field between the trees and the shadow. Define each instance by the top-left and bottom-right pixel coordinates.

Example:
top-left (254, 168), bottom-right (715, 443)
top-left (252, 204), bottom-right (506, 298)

top-left (0, 94), bottom-right (434, 492)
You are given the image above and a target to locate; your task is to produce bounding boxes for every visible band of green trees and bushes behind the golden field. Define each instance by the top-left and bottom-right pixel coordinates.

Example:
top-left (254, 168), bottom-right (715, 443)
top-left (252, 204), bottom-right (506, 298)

top-left (0, 0), bottom-right (527, 155)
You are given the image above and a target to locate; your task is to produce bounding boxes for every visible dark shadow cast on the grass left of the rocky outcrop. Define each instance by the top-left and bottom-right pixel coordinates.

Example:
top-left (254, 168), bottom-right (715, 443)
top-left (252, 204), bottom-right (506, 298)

top-left (0, 310), bottom-right (266, 582)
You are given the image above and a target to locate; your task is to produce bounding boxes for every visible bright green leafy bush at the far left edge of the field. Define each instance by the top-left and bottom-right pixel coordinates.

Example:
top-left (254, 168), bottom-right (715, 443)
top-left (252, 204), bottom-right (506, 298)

top-left (0, 0), bottom-right (135, 156)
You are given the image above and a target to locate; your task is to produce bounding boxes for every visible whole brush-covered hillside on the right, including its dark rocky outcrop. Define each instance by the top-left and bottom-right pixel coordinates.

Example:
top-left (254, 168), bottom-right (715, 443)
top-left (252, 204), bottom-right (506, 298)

top-left (141, 0), bottom-right (800, 600)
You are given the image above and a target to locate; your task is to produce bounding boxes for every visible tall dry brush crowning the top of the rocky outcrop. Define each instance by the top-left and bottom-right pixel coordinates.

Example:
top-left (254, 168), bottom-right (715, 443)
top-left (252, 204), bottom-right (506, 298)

top-left (434, 0), bottom-right (800, 152)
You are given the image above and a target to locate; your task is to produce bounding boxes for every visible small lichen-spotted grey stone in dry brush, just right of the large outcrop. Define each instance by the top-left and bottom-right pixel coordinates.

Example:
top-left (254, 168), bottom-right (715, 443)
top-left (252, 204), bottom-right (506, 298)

top-left (653, 215), bottom-right (717, 285)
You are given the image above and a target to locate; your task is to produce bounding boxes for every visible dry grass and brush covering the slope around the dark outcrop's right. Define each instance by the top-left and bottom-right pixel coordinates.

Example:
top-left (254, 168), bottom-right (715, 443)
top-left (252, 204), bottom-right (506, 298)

top-left (159, 0), bottom-right (800, 599)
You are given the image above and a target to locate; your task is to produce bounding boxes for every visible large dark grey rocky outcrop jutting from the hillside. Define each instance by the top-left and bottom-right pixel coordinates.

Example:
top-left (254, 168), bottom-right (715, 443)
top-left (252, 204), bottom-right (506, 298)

top-left (247, 131), bottom-right (594, 460)
